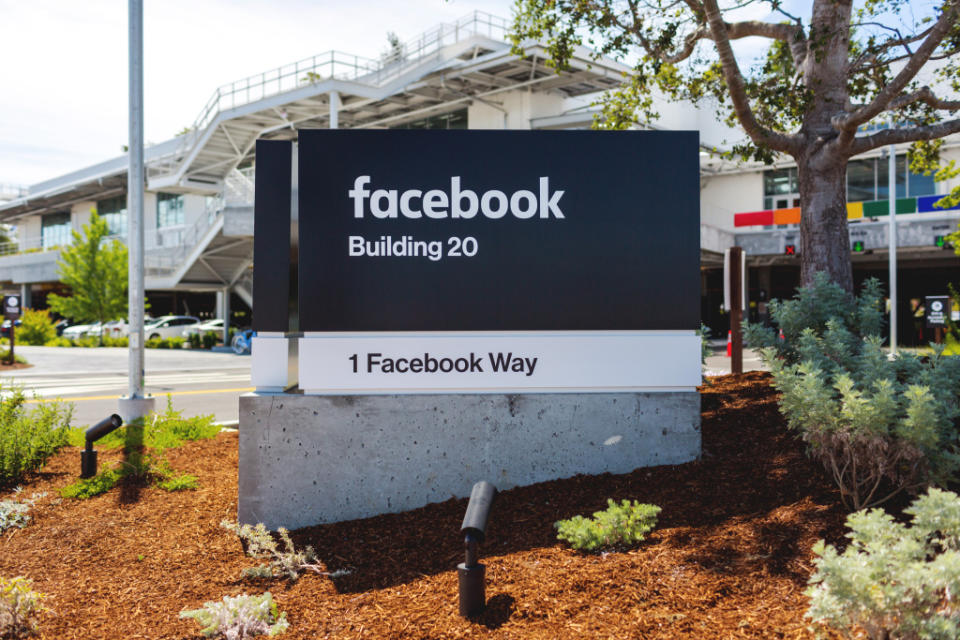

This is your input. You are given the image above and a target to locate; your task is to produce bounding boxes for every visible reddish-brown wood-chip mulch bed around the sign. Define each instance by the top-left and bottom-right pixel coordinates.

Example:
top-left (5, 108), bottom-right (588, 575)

top-left (0, 373), bottom-right (844, 640)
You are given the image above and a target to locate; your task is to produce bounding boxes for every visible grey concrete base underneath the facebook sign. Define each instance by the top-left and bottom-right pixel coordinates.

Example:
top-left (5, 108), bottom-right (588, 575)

top-left (238, 391), bottom-right (700, 529)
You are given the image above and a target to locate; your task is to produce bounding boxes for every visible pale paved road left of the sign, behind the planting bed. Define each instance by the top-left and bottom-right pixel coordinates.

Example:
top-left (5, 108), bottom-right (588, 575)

top-left (0, 346), bottom-right (252, 426)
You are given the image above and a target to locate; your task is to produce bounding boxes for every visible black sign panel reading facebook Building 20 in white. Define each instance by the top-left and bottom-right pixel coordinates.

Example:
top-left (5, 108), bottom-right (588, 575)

top-left (294, 130), bottom-right (700, 331)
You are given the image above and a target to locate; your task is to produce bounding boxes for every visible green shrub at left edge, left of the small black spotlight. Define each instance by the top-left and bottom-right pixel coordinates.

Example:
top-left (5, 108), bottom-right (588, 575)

top-left (0, 382), bottom-right (73, 485)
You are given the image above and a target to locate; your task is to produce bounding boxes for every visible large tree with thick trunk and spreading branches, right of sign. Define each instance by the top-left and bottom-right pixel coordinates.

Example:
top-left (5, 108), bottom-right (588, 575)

top-left (512, 0), bottom-right (960, 292)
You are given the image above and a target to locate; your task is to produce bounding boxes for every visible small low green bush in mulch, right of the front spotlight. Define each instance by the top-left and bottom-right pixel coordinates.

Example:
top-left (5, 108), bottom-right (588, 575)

top-left (553, 500), bottom-right (660, 551)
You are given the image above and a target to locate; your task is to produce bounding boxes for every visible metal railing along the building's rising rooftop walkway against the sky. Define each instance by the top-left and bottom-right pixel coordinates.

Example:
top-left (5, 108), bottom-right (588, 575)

top-left (152, 11), bottom-right (510, 170)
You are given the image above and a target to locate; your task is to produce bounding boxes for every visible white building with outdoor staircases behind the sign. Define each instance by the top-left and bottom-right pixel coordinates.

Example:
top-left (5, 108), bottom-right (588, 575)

top-left (0, 12), bottom-right (960, 336)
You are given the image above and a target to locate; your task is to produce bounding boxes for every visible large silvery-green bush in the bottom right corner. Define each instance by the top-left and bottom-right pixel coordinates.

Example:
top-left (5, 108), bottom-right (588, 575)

top-left (806, 489), bottom-right (960, 640)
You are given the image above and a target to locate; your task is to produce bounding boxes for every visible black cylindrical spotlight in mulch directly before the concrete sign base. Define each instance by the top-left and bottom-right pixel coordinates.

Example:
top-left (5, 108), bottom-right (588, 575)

top-left (457, 481), bottom-right (497, 618)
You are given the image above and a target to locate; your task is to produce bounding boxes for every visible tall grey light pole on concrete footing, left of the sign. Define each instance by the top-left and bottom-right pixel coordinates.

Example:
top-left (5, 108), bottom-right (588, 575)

top-left (119, 0), bottom-right (153, 423)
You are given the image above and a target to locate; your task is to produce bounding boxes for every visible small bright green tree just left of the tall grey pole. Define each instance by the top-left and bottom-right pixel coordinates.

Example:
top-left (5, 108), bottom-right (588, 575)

top-left (47, 211), bottom-right (127, 344)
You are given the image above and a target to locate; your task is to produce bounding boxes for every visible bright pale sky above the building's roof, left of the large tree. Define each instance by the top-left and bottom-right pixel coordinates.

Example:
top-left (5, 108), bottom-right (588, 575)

top-left (0, 0), bottom-right (513, 185)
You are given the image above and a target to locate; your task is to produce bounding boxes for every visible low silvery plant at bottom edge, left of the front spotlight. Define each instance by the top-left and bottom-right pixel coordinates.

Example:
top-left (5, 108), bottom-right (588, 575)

top-left (180, 591), bottom-right (290, 640)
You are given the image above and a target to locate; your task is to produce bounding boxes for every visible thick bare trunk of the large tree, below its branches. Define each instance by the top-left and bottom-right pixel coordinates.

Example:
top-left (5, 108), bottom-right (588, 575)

top-left (796, 150), bottom-right (853, 293)
